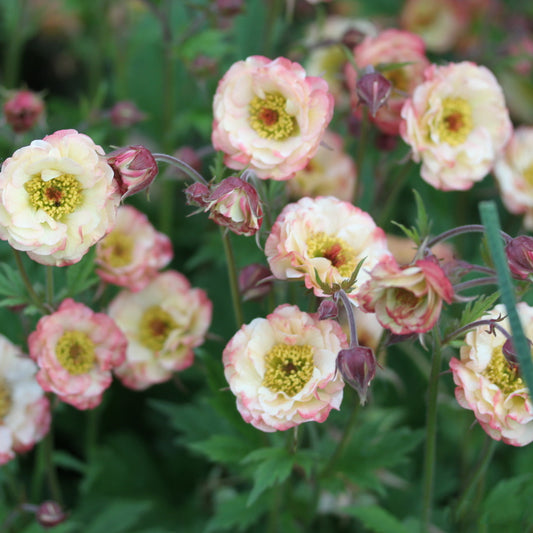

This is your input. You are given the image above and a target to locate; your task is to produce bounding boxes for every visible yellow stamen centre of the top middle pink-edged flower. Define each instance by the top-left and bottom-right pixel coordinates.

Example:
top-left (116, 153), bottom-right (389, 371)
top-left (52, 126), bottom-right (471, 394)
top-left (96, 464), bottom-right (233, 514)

top-left (249, 93), bottom-right (298, 141)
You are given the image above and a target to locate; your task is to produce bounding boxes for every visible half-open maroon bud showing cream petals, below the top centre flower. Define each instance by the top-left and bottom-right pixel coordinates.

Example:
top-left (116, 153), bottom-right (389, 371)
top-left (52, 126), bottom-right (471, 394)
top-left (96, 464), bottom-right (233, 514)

top-left (206, 176), bottom-right (263, 236)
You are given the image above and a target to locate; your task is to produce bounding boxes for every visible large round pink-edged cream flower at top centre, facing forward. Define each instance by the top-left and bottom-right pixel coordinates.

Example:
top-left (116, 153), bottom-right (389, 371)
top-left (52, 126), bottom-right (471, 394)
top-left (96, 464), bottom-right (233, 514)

top-left (212, 56), bottom-right (333, 180)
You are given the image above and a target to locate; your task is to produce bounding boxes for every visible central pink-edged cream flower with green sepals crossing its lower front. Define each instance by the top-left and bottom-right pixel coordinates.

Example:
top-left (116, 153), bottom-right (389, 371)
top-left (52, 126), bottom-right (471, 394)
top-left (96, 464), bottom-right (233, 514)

top-left (265, 196), bottom-right (390, 298)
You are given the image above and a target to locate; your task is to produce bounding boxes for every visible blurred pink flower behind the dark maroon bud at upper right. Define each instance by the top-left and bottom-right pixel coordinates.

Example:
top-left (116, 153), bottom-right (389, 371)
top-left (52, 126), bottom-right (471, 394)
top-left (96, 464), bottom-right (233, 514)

top-left (345, 29), bottom-right (429, 135)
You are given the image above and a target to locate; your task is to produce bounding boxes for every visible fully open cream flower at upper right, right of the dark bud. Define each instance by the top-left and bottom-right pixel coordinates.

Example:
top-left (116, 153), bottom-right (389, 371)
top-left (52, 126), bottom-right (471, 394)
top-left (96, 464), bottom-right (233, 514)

top-left (401, 61), bottom-right (512, 191)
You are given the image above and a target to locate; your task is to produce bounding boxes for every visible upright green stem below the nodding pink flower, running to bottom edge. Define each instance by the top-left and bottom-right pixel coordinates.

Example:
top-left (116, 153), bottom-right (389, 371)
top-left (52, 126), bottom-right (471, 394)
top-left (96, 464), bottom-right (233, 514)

top-left (421, 326), bottom-right (442, 533)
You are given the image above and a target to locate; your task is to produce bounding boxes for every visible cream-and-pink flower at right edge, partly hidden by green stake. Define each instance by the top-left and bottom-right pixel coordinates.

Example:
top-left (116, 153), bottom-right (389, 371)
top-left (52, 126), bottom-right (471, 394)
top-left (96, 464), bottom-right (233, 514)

top-left (450, 302), bottom-right (533, 446)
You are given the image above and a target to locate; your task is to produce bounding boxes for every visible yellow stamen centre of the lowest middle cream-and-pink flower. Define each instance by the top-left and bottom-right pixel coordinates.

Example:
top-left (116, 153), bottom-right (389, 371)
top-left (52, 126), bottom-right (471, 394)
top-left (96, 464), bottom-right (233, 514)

top-left (263, 344), bottom-right (314, 396)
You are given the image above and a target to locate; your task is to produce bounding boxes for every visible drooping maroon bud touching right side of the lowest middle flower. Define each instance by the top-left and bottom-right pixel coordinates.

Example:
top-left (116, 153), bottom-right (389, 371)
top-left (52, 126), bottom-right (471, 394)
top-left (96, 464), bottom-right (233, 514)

top-left (337, 346), bottom-right (377, 405)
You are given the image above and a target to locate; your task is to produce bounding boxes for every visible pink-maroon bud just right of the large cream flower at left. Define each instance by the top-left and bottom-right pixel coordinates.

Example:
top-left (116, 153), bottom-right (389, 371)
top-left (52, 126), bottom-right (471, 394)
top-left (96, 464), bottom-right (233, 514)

top-left (107, 145), bottom-right (159, 198)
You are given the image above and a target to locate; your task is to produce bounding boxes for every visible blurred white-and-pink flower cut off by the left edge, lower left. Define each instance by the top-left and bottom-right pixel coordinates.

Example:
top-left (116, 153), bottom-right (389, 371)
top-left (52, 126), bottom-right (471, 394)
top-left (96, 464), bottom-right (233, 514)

top-left (0, 335), bottom-right (51, 465)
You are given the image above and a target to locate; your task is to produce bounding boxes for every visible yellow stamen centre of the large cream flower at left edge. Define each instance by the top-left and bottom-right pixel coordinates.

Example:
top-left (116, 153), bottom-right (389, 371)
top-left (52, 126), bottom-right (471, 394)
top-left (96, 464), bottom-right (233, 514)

top-left (24, 174), bottom-right (82, 220)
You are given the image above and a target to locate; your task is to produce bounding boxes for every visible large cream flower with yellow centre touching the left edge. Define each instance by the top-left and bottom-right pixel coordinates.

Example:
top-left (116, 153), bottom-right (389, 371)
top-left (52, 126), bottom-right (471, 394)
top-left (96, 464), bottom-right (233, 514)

top-left (0, 130), bottom-right (120, 266)
